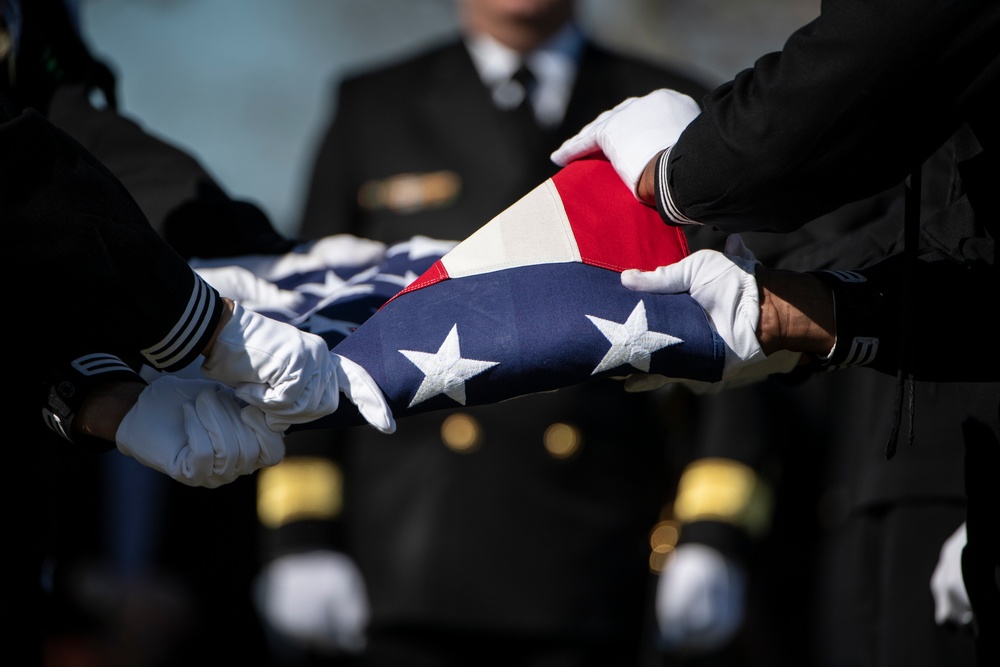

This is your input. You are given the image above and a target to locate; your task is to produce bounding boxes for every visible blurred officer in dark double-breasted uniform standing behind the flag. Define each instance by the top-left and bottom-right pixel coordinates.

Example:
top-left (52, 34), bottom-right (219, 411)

top-left (258, 0), bottom-right (705, 667)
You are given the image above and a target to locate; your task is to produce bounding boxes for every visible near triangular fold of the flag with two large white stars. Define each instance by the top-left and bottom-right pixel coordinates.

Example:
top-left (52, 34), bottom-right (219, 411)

top-left (298, 159), bottom-right (725, 429)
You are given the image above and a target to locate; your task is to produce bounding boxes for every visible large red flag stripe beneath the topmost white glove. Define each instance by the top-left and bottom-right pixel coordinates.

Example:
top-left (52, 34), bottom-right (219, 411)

top-left (552, 158), bottom-right (690, 272)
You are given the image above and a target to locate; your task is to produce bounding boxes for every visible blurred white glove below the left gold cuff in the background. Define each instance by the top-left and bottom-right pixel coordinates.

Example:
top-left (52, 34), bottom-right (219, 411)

top-left (257, 551), bottom-right (369, 653)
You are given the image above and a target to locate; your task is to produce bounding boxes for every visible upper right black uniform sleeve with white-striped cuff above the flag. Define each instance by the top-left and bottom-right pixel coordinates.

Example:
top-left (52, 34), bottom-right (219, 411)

top-left (661, 0), bottom-right (1000, 232)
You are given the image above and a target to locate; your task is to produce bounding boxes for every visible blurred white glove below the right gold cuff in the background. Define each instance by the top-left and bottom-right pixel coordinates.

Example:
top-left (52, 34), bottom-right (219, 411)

top-left (656, 543), bottom-right (746, 653)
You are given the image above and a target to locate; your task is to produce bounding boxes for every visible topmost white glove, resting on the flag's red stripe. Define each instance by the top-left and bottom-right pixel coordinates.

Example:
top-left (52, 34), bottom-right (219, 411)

top-left (550, 88), bottom-right (701, 198)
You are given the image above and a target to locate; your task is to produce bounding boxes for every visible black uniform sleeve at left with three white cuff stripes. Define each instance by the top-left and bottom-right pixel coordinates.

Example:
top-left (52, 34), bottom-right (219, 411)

top-left (0, 109), bottom-right (222, 444)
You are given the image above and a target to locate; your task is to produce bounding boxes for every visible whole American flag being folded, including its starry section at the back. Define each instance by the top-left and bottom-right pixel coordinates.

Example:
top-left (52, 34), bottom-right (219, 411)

top-left (192, 159), bottom-right (725, 430)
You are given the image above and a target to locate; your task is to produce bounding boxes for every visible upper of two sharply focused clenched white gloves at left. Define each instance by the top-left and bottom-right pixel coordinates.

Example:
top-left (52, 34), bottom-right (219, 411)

top-left (202, 303), bottom-right (340, 433)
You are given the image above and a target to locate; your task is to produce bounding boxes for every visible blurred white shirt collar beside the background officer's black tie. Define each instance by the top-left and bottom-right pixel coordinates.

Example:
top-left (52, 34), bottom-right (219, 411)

top-left (466, 23), bottom-right (584, 127)
